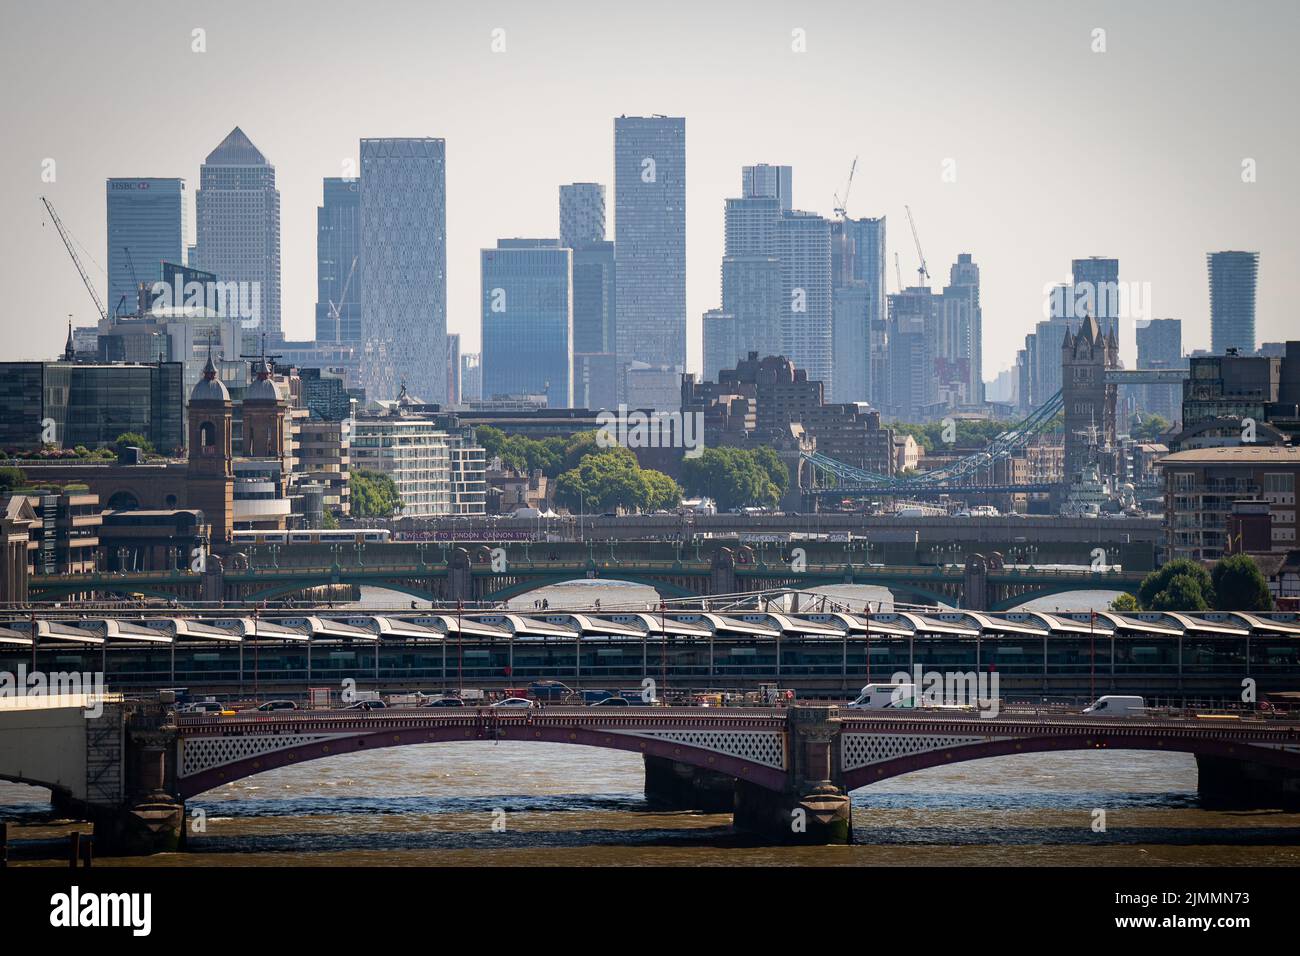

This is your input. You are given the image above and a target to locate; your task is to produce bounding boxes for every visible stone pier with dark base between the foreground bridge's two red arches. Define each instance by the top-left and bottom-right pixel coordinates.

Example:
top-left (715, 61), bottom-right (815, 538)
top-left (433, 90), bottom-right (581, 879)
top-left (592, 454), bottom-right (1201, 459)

top-left (733, 705), bottom-right (853, 845)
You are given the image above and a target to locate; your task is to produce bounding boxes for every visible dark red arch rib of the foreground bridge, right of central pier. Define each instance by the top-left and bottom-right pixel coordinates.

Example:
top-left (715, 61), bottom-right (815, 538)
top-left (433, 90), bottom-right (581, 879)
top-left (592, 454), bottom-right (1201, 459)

top-left (841, 731), bottom-right (1300, 791)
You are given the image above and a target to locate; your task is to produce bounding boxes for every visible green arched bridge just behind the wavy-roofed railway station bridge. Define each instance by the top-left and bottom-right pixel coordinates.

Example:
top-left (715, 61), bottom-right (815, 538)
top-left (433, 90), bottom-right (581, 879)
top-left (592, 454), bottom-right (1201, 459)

top-left (30, 541), bottom-right (1151, 610)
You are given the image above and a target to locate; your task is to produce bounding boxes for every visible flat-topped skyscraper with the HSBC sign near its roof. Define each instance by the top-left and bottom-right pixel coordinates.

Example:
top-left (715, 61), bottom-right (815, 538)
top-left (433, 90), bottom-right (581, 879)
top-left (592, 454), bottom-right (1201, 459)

top-left (105, 178), bottom-right (185, 315)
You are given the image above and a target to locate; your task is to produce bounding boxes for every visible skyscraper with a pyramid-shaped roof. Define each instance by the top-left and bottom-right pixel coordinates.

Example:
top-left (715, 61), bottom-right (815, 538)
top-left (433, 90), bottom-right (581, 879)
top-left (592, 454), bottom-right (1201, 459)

top-left (189, 126), bottom-right (282, 339)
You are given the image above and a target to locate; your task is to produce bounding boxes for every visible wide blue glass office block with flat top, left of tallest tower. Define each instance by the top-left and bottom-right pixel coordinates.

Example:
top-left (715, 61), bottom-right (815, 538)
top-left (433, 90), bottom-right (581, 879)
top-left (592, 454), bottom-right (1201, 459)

top-left (480, 239), bottom-right (573, 408)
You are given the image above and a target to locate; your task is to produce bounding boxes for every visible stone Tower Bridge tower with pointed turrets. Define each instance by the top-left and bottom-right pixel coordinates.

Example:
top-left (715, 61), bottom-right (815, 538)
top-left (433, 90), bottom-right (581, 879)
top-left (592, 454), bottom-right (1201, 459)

top-left (1061, 316), bottom-right (1119, 481)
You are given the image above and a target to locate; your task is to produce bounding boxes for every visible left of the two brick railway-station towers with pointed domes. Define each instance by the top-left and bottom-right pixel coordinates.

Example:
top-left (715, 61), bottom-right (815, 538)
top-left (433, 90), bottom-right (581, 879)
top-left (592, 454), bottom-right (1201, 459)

top-left (186, 349), bottom-right (235, 550)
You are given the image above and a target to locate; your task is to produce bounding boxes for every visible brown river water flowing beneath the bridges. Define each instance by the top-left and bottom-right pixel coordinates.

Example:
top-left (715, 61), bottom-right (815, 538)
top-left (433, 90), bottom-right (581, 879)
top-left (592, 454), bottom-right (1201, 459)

top-left (0, 584), bottom-right (1300, 866)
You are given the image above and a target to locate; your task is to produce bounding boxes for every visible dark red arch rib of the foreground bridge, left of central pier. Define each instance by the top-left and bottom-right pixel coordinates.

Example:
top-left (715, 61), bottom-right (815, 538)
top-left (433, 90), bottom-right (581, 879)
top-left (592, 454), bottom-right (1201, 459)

top-left (177, 722), bottom-right (787, 800)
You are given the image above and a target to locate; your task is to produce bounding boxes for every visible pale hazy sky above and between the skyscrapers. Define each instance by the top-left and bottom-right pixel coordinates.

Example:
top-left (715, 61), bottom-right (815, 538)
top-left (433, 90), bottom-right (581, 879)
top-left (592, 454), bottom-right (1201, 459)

top-left (0, 0), bottom-right (1300, 378)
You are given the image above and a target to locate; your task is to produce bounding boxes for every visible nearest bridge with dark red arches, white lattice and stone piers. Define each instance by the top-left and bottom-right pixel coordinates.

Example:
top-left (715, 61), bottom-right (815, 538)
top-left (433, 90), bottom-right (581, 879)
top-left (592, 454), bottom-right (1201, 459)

top-left (0, 698), bottom-right (1300, 852)
